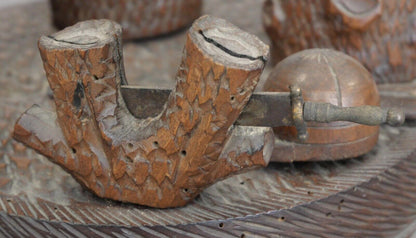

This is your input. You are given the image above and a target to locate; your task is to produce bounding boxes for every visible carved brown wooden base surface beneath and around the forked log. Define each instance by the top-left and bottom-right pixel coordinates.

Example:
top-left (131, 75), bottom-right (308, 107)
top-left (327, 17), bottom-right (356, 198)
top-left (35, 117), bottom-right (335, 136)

top-left (0, 0), bottom-right (416, 238)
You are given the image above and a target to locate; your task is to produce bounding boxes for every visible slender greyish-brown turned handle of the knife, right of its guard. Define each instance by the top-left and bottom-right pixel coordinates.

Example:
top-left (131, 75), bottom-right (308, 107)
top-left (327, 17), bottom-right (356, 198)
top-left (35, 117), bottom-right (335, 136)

top-left (303, 102), bottom-right (405, 126)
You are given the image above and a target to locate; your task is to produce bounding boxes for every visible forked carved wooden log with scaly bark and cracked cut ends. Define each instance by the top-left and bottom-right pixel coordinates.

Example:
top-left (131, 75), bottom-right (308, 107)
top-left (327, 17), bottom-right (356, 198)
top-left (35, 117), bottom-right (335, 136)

top-left (14, 16), bottom-right (273, 208)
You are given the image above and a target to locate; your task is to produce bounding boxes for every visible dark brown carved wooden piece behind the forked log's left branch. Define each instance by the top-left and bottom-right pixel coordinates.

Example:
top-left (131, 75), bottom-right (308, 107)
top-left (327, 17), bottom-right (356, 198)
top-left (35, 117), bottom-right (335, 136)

top-left (50, 0), bottom-right (202, 39)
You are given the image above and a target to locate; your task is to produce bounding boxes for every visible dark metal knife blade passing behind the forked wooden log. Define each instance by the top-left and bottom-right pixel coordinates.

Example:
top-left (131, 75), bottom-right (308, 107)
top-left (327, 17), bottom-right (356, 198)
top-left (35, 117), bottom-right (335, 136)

top-left (121, 85), bottom-right (293, 127)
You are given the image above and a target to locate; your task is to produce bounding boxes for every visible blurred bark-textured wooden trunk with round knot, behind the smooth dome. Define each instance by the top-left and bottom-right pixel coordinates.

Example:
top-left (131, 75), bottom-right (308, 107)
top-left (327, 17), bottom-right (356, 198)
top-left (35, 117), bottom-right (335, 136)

top-left (263, 0), bottom-right (416, 83)
